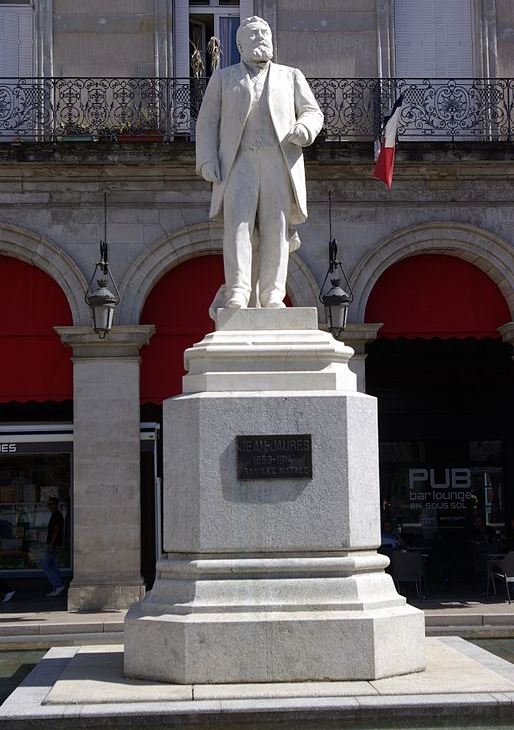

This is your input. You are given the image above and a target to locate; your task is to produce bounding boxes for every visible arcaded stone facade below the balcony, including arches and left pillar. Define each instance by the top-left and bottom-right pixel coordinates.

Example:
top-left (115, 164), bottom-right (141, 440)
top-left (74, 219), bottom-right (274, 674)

top-left (0, 141), bottom-right (508, 611)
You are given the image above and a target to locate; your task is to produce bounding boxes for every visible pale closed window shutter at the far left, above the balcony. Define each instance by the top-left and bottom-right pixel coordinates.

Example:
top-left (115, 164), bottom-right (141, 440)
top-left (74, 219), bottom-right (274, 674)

top-left (0, 6), bottom-right (33, 78)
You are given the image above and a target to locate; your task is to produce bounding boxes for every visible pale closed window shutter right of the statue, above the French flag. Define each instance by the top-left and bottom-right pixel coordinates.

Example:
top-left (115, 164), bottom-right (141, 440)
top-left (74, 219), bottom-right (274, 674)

top-left (394, 0), bottom-right (473, 78)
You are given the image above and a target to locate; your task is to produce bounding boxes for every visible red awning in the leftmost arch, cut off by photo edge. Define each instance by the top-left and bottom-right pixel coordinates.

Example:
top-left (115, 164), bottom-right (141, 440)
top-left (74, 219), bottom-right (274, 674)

top-left (0, 256), bottom-right (73, 403)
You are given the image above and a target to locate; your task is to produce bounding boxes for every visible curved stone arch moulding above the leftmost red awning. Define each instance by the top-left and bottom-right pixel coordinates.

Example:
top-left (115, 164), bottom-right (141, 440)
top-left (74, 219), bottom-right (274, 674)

top-left (0, 223), bottom-right (90, 325)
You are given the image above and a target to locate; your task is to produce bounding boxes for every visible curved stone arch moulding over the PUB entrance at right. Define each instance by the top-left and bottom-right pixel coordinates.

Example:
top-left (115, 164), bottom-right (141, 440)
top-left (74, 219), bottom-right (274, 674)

top-left (350, 221), bottom-right (514, 322)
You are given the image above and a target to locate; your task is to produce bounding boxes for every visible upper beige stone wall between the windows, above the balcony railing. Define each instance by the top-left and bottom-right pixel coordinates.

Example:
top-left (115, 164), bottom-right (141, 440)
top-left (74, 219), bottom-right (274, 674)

top-left (43, 0), bottom-right (514, 77)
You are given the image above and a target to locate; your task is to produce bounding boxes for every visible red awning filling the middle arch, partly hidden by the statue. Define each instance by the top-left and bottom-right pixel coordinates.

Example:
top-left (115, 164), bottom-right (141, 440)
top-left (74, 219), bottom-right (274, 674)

top-left (141, 254), bottom-right (290, 403)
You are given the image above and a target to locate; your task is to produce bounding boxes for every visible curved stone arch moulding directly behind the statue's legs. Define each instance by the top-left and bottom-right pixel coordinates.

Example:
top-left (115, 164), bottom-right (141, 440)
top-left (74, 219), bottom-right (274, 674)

top-left (118, 222), bottom-right (325, 324)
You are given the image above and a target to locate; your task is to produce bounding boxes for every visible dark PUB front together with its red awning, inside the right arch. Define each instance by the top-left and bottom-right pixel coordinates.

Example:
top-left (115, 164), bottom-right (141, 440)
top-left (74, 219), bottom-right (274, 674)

top-left (366, 255), bottom-right (514, 596)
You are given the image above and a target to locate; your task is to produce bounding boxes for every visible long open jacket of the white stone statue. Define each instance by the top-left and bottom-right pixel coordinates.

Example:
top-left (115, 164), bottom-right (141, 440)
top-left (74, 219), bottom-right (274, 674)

top-left (196, 62), bottom-right (323, 225)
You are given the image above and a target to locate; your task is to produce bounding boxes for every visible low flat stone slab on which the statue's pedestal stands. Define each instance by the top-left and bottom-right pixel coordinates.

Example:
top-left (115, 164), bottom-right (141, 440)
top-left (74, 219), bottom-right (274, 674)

top-left (2, 637), bottom-right (514, 728)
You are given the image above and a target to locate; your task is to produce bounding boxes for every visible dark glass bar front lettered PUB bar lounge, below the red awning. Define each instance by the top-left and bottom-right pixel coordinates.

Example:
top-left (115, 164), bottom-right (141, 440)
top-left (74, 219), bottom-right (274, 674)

top-left (380, 438), bottom-right (506, 584)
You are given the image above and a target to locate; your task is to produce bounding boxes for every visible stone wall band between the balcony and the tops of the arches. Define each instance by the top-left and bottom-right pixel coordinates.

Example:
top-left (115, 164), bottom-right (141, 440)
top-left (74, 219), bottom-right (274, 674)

top-left (0, 142), bottom-right (514, 324)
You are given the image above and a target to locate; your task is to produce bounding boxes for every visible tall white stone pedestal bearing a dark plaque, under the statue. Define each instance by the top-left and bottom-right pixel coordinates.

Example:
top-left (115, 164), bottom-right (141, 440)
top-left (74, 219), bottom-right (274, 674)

top-left (125, 308), bottom-right (424, 683)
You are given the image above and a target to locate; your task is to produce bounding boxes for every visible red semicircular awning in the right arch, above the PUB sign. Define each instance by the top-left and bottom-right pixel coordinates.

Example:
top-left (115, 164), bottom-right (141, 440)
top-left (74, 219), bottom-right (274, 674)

top-left (365, 254), bottom-right (510, 339)
